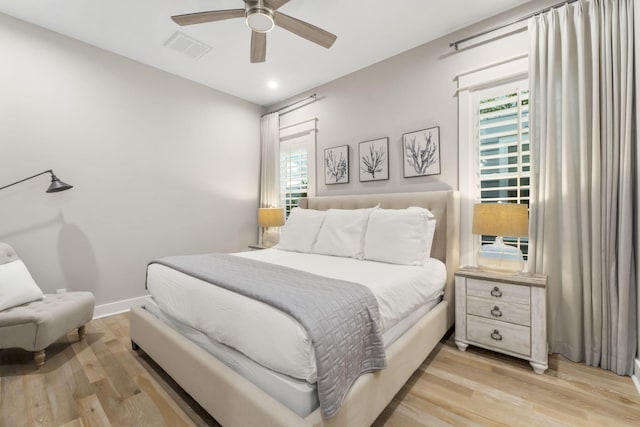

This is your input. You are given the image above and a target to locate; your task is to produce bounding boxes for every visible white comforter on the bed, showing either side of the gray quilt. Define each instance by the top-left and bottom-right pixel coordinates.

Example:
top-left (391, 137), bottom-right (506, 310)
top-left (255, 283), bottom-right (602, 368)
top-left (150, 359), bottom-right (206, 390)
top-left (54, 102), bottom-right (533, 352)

top-left (147, 249), bottom-right (446, 383)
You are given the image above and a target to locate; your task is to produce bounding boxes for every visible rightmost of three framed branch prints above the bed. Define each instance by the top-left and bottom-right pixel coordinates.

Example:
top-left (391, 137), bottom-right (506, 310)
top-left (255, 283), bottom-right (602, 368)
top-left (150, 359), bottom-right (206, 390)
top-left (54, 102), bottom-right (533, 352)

top-left (402, 126), bottom-right (440, 178)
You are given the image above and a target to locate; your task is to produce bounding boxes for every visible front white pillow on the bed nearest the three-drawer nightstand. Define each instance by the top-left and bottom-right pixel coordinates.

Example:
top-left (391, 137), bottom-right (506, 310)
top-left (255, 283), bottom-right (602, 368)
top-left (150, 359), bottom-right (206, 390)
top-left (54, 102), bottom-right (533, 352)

top-left (364, 207), bottom-right (436, 265)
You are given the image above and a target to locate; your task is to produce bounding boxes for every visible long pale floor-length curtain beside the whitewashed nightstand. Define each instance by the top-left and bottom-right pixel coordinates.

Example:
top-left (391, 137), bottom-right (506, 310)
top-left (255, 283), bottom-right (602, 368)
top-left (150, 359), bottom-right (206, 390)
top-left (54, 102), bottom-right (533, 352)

top-left (529, 0), bottom-right (638, 375)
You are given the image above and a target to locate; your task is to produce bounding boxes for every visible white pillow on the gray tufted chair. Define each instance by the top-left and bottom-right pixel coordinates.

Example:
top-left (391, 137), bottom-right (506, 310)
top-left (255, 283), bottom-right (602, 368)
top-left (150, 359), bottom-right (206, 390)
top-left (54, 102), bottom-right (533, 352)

top-left (0, 259), bottom-right (44, 311)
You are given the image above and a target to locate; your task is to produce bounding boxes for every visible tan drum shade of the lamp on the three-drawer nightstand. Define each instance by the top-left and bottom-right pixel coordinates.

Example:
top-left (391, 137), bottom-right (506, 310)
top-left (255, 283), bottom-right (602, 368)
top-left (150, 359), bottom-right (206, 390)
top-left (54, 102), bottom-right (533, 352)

top-left (471, 203), bottom-right (529, 237)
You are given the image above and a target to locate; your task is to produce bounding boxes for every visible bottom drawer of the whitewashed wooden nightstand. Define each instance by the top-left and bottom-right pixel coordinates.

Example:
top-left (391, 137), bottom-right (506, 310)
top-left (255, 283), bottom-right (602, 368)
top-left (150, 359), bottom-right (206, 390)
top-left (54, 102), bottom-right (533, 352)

top-left (467, 315), bottom-right (531, 357)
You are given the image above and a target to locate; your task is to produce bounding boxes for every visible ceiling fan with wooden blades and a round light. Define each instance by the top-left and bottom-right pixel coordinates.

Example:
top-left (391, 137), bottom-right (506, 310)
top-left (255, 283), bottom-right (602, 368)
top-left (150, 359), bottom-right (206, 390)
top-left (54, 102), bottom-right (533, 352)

top-left (171, 0), bottom-right (337, 63)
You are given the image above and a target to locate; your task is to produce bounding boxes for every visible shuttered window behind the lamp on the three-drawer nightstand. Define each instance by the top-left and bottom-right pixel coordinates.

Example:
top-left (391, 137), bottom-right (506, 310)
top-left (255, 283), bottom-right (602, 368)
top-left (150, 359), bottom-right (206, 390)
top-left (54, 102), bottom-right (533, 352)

top-left (474, 81), bottom-right (531, 260)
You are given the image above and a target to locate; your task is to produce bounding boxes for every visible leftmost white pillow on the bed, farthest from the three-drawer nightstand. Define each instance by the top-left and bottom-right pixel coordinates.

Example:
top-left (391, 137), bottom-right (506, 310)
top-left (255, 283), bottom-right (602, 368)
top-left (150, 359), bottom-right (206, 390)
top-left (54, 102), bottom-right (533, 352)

top-left (275, 208), bottom-right (327, 253)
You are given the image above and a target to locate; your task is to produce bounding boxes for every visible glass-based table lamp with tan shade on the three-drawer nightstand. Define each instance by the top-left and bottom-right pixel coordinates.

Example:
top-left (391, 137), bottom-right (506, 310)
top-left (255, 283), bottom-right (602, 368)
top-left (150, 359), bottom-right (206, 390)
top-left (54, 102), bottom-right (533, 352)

top-left (471, 203), bottom-right (529, 274)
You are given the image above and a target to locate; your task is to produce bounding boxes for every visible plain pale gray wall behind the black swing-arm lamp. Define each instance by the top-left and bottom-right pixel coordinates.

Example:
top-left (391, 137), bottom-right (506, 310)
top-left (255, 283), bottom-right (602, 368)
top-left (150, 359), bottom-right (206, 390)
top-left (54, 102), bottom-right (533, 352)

top-left (0, 14), bottom-right (260, 304)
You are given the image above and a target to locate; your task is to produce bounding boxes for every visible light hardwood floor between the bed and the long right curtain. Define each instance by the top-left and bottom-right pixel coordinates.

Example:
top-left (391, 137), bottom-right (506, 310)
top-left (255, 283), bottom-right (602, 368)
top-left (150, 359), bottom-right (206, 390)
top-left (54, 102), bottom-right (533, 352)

top-left (374, 342), bottom-right (640, 427)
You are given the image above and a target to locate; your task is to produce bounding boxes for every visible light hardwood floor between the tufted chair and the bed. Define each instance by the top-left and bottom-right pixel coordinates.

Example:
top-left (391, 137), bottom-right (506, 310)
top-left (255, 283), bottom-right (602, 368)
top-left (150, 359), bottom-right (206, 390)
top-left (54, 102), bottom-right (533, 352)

top-left (0, 313), bottom-right (218, 427)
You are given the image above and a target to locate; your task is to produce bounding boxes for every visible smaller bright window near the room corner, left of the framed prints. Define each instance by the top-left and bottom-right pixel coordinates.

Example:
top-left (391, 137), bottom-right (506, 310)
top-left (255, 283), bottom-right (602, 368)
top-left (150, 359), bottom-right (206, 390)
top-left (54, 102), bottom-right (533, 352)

top-left (280, 119), bottom-right (316, 217)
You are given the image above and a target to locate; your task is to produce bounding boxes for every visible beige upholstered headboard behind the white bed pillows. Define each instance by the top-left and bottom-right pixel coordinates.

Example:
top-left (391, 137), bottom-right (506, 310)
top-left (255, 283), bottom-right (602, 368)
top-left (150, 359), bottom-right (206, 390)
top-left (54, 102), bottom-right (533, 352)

top-left (298, 191), bottom-right (460, 326)
